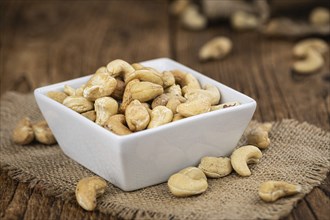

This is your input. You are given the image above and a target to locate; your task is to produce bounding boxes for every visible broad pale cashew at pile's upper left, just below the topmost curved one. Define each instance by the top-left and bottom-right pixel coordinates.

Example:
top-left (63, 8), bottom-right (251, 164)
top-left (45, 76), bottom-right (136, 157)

top-left (83, 72), bottom-right (117, 101)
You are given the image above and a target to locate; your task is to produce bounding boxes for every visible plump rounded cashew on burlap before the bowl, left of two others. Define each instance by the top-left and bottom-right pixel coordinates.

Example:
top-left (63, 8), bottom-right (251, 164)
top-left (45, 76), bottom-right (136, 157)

top-left (167, 167), bottom-right (208, 197)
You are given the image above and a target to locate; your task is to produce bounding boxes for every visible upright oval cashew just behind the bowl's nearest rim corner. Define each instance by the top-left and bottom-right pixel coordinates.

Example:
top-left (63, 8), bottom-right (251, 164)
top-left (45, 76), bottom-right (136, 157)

top-left (125, 100), bottom-right (150, 131)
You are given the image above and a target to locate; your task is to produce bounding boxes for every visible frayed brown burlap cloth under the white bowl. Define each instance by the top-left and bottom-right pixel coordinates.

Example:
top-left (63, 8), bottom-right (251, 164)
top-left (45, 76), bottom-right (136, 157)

top-left (0, 93), bottom-right (330, 219)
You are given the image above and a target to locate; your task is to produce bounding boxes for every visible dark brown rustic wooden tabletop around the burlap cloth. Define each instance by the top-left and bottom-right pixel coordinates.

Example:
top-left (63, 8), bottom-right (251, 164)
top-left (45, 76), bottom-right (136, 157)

top-left (0, 0), bottom-right (330, 220)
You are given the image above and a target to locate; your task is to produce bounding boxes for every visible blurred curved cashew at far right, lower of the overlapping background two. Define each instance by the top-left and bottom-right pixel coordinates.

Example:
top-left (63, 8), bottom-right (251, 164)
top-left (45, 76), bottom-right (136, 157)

top-left (293, 49), bottom-right (324, 74)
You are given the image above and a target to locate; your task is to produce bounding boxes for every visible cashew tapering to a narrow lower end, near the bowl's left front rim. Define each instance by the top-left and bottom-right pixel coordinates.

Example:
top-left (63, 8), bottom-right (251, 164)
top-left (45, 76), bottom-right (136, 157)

top-left (94, 97), bottom-right (118, 126)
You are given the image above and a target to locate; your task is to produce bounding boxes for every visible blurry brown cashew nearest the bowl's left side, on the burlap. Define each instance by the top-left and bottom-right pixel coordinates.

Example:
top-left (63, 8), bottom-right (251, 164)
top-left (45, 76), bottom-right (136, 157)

top-left (32, 120), bottom-right (56, 145)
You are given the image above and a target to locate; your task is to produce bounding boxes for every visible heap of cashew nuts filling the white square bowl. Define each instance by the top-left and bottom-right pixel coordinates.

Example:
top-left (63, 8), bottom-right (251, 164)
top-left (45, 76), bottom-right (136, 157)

top-left (47, 59), bottom-right (239, 135)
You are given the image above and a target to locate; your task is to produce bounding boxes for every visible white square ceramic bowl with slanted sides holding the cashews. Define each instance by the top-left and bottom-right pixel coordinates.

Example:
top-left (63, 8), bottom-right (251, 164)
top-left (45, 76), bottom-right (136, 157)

top-left (34, 58), bottom-right (256, 191)
